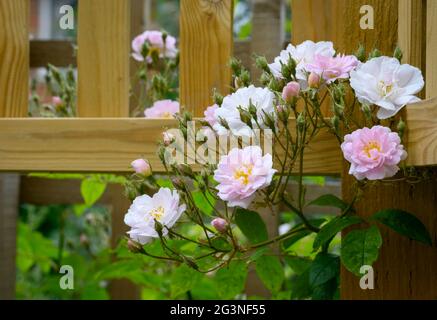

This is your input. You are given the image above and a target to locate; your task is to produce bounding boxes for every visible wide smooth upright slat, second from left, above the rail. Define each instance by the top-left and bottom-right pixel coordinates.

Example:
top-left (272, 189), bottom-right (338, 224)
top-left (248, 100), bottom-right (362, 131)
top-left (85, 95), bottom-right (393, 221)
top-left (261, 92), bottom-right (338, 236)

top-left (77, 0), bottom-right (130, 117)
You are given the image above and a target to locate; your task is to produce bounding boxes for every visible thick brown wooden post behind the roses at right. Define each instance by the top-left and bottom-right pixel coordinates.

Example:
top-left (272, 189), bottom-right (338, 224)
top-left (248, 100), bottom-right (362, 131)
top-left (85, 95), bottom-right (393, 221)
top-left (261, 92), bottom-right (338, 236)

top-left (341, 0), bottom-right (437, 299)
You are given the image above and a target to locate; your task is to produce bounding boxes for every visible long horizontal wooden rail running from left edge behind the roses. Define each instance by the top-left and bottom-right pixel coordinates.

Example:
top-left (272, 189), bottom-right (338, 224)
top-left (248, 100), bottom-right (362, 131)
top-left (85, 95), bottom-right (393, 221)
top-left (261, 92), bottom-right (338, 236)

top-left (0, 118), bottom-right (341, 175)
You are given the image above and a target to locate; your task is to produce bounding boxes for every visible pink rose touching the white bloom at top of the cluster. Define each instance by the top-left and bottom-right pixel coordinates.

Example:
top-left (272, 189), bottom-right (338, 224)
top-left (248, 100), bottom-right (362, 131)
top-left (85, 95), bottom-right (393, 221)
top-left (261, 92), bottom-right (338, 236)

top-left (306, 55), bottom-right (358, 83)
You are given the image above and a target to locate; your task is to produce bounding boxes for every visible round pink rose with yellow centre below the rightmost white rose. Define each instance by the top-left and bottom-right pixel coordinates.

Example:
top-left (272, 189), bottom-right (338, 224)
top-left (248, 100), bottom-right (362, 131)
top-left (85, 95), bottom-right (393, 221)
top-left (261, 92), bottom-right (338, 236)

top-left (341, 126), bottom-right (407, 180)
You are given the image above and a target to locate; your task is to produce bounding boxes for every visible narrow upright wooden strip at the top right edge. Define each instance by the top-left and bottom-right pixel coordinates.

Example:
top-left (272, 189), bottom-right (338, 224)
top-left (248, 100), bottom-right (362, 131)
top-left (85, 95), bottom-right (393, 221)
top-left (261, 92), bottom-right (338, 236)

top-left (426, 0), bottom-right (437, 99)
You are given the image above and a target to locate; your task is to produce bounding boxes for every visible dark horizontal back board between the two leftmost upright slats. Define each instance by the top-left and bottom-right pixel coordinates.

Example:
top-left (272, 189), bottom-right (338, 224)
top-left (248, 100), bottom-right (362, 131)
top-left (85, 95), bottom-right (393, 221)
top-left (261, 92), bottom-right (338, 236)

top-left (30, 40), bottom-right (77, 68)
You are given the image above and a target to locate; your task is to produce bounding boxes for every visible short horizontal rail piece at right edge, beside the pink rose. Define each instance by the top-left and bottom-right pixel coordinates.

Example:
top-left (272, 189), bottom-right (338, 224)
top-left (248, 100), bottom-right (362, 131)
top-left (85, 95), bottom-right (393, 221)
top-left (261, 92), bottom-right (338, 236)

top-left (405, 98), bottom-right (437, 166)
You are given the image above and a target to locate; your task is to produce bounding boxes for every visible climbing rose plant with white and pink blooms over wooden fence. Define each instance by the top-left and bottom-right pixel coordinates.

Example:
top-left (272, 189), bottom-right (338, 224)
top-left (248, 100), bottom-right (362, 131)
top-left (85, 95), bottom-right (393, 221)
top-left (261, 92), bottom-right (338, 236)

top-left (124, 38), bottom-right (432, 298)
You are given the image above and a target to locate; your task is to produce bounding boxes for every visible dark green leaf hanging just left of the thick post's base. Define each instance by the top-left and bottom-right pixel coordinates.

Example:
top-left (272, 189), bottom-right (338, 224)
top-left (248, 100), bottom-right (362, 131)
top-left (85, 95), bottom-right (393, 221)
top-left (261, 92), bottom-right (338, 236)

top-left (309, 252), bottom-right (340, 288)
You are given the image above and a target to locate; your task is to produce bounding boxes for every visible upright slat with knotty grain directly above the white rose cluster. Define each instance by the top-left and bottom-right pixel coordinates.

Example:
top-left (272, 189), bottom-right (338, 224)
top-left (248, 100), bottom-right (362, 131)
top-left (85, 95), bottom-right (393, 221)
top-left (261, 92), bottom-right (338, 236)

top-left (179, 0), bottom-right (233, 116)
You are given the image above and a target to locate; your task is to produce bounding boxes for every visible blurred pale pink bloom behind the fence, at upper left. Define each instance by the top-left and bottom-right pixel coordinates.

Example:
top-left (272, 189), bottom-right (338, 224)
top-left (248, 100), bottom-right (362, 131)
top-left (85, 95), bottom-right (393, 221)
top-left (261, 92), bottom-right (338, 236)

top-left (132, 30), bottom-right (178, 63)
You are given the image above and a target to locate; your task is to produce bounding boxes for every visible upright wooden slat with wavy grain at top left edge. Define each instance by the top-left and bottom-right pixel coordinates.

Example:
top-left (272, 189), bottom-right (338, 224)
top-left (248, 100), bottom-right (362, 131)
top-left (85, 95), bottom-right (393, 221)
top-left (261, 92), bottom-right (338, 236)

top-left (0, 0), bottom-right (29, 117)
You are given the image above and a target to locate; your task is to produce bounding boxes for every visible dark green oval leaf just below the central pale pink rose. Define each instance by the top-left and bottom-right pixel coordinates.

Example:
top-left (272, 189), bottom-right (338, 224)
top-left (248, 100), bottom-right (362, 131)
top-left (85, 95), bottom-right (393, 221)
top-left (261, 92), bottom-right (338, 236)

top-left (235, 208), bottom-right (269, 244)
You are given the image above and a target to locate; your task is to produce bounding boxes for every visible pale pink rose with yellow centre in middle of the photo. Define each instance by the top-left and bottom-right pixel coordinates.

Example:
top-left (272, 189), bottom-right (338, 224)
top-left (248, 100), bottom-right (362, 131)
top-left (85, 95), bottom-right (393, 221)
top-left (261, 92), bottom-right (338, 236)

top-left (214, 146), bottom-right (276, 208)
